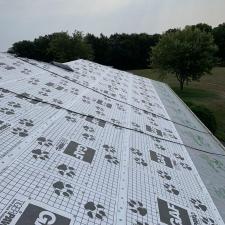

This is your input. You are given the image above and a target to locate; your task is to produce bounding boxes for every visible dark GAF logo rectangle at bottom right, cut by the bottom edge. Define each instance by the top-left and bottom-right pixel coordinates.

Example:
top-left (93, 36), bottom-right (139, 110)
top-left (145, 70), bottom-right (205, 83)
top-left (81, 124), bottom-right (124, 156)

top-left (158, 198), bottom-right (192, 225)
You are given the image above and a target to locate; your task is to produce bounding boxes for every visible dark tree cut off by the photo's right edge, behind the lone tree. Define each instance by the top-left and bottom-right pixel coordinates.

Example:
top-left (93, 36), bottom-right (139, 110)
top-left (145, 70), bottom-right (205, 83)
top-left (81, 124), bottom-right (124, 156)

top-left (213, 23), bottom-right (225, 63)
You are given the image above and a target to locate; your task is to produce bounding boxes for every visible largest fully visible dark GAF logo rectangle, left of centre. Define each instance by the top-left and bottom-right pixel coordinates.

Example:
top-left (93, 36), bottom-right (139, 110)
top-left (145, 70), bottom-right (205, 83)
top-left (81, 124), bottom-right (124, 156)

top-left (64, 141), bottom-right (95, 163)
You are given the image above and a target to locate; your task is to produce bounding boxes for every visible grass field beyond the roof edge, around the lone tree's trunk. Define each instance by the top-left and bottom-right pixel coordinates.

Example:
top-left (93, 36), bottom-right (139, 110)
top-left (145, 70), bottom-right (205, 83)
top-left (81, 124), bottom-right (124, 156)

top-left (130, 67), bottom-right (225, 142)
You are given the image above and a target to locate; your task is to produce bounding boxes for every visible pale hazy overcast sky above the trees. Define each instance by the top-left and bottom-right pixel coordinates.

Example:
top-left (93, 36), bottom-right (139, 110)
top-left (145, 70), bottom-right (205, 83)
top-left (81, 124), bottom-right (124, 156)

top-left (0, 0), bottom-right (225, 51)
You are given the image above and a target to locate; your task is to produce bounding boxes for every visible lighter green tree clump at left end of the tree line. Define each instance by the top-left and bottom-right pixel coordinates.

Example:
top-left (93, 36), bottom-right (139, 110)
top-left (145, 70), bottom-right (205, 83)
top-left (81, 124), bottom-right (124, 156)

top-left (8, 31), bottom-right (93, 62)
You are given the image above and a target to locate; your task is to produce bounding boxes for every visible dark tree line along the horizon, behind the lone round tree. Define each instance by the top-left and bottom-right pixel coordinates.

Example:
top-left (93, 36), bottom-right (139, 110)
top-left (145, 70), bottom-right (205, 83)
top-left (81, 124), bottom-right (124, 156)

top-left (8, 23), bottom-right (225, 70)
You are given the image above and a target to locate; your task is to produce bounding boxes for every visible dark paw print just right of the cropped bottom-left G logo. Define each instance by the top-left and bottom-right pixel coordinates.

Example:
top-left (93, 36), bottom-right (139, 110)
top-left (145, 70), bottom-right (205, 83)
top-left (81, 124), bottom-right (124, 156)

top-left (84, 202), bottom-right (106, 220)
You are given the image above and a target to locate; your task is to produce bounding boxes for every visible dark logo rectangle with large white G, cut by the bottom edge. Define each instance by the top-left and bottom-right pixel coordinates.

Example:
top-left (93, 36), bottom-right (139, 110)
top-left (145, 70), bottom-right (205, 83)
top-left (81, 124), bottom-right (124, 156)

top-left (14, 204), bottom-right (71, 225)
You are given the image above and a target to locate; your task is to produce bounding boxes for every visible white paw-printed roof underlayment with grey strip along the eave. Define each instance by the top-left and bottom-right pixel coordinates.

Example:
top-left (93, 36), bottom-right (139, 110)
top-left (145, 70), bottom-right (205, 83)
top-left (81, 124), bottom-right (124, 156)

top-left (0, 53), bottom-right (225, 225)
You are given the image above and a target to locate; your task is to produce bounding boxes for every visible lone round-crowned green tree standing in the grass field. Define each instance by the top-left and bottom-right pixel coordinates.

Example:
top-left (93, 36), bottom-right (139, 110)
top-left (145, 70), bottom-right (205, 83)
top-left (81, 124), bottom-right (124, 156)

top-left (152, 27), bottom-right (217, 90)
